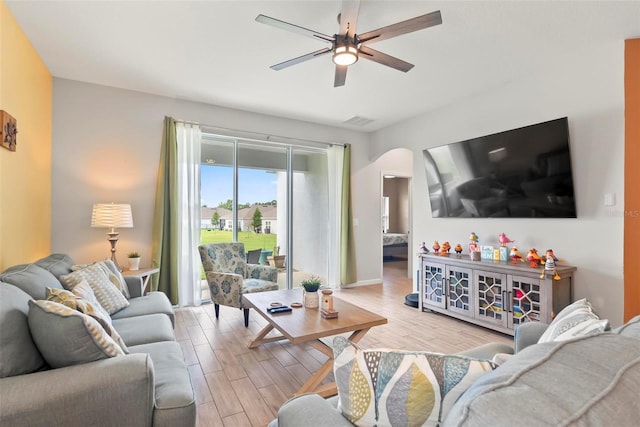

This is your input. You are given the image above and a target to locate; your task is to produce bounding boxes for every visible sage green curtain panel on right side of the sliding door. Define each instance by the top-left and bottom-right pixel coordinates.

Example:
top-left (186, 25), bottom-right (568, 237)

top-left (340, 144), bottom-right (357, 286)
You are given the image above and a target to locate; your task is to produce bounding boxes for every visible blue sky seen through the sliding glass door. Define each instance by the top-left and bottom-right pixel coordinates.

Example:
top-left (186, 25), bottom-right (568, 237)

top-left (200, 165), bottom-right (278, 208)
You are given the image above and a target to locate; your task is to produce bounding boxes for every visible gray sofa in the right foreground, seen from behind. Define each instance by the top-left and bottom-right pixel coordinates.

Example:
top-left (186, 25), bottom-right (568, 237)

top-left (269, 316), bottom-right (640, 427)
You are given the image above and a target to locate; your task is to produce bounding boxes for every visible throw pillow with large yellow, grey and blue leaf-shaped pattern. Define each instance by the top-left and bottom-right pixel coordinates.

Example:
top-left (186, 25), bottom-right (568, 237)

top-left (333, 337), bottom-right (495, 426)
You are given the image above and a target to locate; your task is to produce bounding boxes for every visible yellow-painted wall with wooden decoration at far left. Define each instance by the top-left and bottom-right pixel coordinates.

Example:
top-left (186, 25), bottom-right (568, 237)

top-left (0, 0), bottom-right (53, 271)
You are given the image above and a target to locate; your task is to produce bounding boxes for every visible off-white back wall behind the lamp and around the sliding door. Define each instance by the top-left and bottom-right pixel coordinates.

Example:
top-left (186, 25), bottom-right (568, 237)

top-left (51, 78), bottom-right (372, 280)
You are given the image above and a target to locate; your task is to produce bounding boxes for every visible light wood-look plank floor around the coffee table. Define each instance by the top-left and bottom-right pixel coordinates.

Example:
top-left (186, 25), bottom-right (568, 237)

top-left (175, 261), bottom-right (512, 426)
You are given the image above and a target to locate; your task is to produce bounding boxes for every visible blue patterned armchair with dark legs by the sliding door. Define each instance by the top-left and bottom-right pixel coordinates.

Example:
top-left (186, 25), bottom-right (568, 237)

top-left (198, 242), bottom-right (278, 327)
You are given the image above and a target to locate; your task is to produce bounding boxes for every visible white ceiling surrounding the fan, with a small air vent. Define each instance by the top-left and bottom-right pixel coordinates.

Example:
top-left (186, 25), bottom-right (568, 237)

top-left (6, 0), bottom-right (640, 131)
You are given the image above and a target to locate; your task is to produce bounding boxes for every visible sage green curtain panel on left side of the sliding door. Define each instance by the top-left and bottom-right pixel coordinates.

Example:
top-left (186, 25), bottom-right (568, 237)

top-left (151, 117), bottom-right (180, 304)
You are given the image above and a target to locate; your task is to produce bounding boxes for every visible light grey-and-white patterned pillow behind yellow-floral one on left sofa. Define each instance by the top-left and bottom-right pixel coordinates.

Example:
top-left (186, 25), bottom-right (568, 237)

top-left (60, 264), bottom-right (129, 314)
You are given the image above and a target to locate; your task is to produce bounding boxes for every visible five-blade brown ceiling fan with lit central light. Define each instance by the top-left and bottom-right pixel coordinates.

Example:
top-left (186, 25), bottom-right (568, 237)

top-left (256, 0), bottom-right (442, 87)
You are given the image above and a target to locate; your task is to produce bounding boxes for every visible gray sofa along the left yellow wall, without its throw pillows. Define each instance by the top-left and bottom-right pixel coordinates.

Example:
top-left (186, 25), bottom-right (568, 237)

top-left (0, 254), bottom-right (196, 426)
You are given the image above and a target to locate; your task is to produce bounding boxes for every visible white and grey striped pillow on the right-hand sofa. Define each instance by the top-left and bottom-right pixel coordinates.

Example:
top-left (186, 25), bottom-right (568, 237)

top-left (538, 298), bottom-right (610, 343)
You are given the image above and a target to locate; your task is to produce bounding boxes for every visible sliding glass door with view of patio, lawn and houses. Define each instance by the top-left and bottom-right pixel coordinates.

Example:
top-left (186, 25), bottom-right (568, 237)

top-left (201, 134), bottom-right (335, 298)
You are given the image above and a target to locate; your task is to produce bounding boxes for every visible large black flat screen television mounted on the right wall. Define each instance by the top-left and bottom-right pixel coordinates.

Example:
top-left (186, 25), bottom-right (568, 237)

top-left (423, 117), bottom-right (576, 218)
